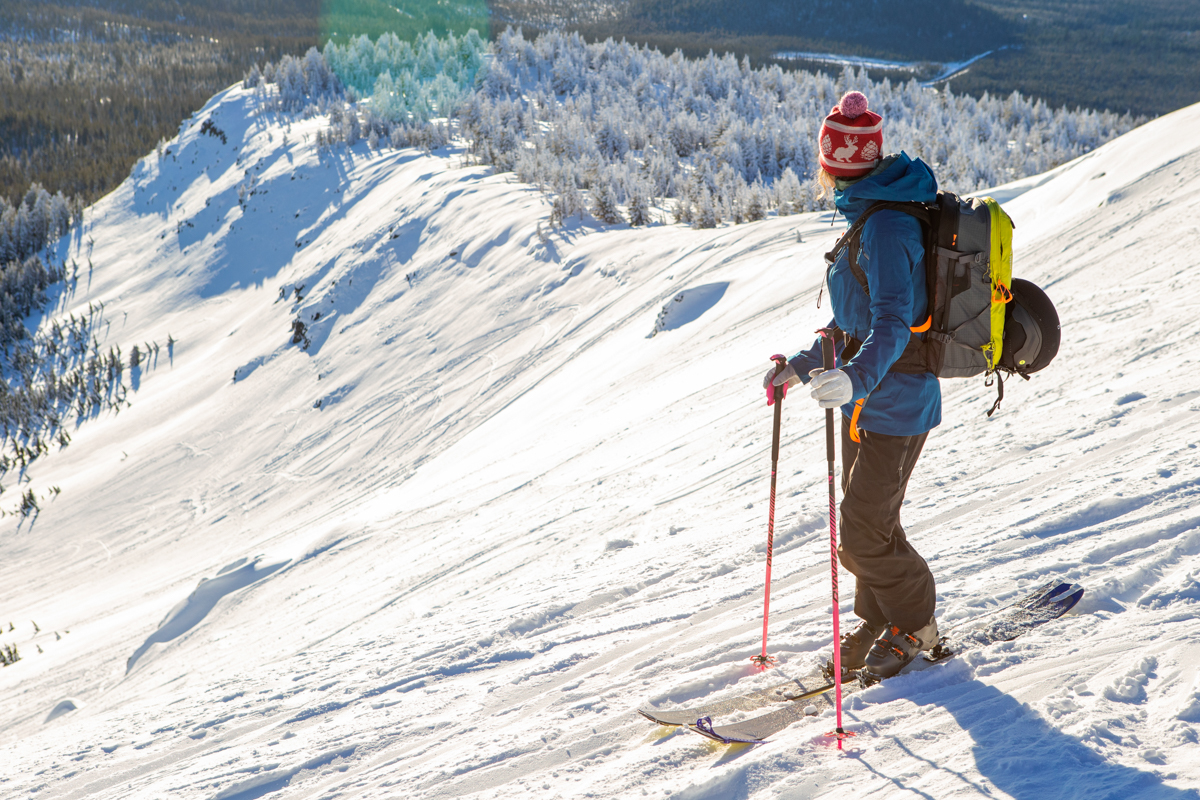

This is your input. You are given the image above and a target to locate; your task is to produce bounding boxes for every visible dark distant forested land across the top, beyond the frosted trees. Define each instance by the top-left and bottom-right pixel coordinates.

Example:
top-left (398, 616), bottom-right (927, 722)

top-left (0, 0), bottom-right (1200, 212)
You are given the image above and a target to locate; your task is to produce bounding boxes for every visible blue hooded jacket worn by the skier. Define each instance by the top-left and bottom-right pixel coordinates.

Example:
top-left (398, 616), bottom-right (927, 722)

top-left (790, 152), bottom-right (942, 437)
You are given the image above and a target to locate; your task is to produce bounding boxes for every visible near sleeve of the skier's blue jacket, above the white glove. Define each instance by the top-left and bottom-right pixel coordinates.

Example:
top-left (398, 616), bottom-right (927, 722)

top-left (840, 211), bottom-right (925, 401)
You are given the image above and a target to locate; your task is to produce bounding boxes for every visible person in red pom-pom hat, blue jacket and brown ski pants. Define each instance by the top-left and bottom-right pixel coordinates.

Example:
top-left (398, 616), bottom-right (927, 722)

top-left (763, 91), bottom-right (942, 678)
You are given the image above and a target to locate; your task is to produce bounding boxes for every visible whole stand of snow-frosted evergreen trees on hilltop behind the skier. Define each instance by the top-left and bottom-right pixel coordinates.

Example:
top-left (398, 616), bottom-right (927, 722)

top-left (258, 30), bottom-right (1138, 225)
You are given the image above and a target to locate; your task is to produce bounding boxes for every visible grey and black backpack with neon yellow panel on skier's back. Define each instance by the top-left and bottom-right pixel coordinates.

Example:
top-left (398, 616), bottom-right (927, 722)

top-left (826, 192), bottom-right (1060, 416)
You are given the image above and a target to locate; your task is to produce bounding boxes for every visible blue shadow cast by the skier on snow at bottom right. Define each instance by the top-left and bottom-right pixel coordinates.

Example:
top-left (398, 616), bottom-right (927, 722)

top-left (858, 680), bottom-right (1200, 800)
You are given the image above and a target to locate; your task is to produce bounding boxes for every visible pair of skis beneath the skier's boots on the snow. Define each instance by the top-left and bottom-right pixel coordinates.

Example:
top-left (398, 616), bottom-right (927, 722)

top-left (638, 582), bottom-right (1084, 744)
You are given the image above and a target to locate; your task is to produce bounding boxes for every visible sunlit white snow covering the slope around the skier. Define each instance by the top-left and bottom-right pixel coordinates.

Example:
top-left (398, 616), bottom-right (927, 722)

top-left (0, 88), bottom-right (1200, 800)
